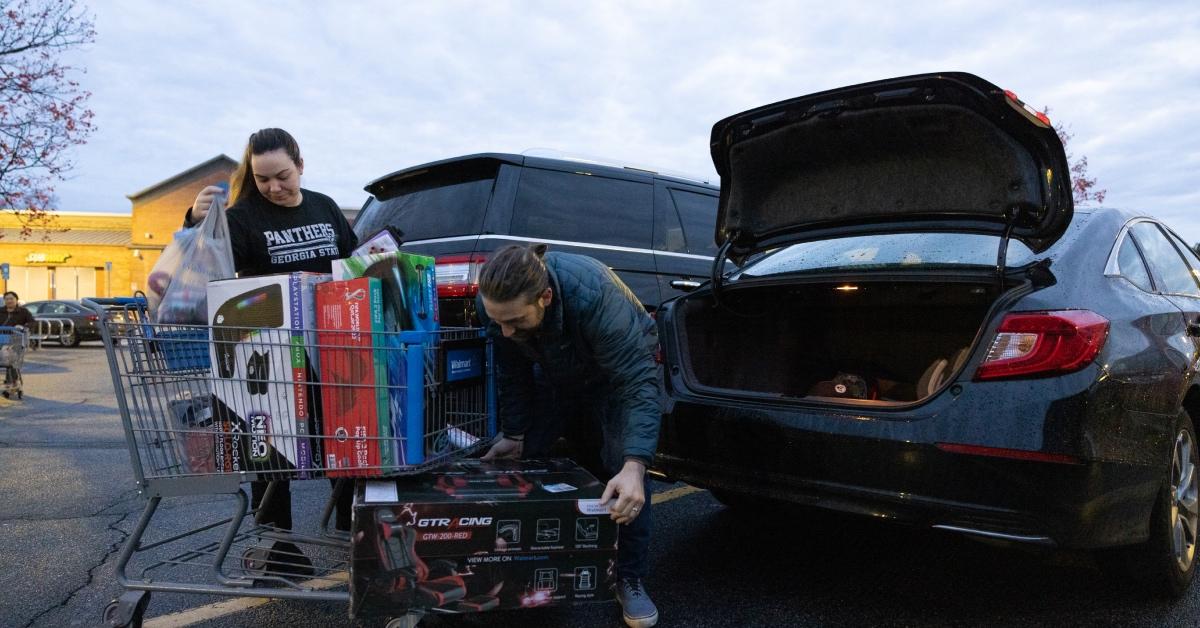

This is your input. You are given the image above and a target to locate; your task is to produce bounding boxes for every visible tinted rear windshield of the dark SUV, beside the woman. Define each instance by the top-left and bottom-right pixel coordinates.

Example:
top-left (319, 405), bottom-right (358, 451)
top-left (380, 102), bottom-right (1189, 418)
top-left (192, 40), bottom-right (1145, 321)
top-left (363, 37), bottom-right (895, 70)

top-left (354, 162), bottom-right (498, 241)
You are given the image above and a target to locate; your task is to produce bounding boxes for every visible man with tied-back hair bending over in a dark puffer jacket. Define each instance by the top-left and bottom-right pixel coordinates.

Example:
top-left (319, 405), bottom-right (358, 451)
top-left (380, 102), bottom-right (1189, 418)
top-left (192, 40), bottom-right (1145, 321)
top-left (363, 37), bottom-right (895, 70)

top-left (478, 245), bottom-right (661, 628)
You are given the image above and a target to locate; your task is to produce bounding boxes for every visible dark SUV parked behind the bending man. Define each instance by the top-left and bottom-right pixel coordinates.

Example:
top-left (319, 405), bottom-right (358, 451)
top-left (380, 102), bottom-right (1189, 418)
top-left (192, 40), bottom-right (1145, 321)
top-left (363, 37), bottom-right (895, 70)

top-left (354, 152), bottom-right (718, 325)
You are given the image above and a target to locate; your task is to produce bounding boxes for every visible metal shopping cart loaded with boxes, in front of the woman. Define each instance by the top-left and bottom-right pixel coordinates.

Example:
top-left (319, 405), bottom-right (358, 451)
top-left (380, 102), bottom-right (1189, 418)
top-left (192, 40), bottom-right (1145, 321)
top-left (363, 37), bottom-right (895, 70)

top-left (85, 298), bottom-right (497, 628)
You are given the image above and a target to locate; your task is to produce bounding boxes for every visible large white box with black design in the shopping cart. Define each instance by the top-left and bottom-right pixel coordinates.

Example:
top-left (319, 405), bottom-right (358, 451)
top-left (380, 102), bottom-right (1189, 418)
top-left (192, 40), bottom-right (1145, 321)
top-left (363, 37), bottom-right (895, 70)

top-left (208, 273), bottom-right (330, 477)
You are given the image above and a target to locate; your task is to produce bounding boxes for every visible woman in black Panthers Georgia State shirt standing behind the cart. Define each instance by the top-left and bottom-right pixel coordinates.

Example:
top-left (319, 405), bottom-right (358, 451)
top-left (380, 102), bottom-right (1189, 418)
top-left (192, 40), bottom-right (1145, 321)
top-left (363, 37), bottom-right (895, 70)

top-left (184, 128), bottom-right (358, 571)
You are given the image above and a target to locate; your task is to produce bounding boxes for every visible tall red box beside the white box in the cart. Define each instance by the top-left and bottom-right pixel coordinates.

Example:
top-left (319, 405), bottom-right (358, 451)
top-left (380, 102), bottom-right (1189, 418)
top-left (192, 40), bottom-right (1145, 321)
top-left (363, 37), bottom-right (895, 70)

top-left (317, 277), bottom-right (395, 477)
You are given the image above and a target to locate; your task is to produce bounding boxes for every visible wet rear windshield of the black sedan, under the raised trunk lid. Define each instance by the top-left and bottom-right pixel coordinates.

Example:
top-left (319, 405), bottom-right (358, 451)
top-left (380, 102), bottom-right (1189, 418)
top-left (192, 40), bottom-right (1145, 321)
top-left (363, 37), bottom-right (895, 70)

top-left (743, 233), bottom-right (1033, 277)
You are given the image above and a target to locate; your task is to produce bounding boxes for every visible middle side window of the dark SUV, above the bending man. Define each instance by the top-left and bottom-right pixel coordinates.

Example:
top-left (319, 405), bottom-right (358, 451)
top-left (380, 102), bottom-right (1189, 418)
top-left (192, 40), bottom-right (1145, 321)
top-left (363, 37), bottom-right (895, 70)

top-left (509, 168), bottom-right (654, 249)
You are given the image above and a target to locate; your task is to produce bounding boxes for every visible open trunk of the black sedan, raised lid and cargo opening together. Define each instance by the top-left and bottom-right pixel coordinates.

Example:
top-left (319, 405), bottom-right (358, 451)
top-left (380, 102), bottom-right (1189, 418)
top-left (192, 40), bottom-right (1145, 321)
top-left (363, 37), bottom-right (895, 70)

top-left (665, 72), bottom-right (1073, 403)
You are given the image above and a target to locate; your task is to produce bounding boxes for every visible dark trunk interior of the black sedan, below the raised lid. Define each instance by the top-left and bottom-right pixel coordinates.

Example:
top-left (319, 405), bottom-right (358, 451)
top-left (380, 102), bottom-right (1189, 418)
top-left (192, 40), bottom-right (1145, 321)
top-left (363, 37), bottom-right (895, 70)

top-left (673, 281), bottom-right (1017, 403)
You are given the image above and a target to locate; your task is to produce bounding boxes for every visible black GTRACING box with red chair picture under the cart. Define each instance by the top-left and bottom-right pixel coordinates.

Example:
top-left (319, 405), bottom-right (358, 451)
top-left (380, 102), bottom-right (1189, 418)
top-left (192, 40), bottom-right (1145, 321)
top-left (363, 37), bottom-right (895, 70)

top-left (350, 460), bottom-right (617, 615)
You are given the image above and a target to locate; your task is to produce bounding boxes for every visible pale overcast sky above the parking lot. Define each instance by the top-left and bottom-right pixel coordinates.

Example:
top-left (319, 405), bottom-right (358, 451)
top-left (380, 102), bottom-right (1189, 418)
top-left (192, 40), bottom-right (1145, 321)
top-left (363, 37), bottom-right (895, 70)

top-left (51, 0), bottom-right (1200, 241)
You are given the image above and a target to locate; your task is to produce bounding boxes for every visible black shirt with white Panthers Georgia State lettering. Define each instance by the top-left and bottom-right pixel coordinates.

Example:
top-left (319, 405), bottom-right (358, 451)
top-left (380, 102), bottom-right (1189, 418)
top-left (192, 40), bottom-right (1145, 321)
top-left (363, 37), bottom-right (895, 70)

top-left (228, 189), bottom-right (359, 277)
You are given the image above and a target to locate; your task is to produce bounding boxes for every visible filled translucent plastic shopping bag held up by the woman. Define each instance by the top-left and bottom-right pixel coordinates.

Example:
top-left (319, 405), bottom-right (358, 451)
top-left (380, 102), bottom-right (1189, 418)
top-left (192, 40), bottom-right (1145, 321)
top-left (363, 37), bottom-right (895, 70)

top-left (154, 196), bottom-right (234, 324)
